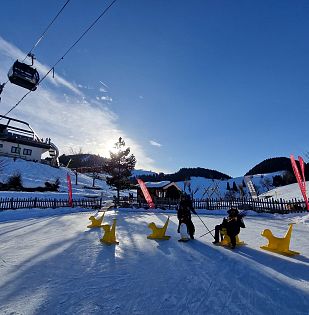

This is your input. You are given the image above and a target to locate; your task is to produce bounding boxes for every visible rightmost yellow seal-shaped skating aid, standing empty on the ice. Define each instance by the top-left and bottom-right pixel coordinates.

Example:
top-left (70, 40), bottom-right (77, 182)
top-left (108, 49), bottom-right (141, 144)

top-left (261, 223), bottom-right (299, 256)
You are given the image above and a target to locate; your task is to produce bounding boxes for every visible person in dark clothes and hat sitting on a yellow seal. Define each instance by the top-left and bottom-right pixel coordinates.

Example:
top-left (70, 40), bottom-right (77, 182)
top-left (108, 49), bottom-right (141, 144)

top-left (213, 208), bottom-right (246, 248)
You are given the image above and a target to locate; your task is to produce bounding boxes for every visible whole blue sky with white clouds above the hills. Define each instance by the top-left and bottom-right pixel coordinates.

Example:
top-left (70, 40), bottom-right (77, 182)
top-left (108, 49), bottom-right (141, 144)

top-left (0, 0), bottom-right (309, 177)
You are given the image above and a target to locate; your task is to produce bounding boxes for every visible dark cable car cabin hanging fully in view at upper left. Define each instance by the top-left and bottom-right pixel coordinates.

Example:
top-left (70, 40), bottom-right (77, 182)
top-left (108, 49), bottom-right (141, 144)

top-left (8, 60), bottom-right (40, 91)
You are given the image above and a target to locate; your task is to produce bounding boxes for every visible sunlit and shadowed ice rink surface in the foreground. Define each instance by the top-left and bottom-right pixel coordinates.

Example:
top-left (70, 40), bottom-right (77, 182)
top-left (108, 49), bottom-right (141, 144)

top-left (0, 212), bottom-right (309, 315)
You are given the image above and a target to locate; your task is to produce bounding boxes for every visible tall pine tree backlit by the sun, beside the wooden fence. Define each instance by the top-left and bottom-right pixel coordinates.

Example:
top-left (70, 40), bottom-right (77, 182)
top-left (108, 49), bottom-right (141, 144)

top-left (104, 137), bottom-right (136, 200)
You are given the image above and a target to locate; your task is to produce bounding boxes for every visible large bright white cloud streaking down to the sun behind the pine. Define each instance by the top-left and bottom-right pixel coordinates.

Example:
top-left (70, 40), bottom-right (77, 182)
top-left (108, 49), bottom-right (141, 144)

top-left (0, 37), bottom-right (160, 171)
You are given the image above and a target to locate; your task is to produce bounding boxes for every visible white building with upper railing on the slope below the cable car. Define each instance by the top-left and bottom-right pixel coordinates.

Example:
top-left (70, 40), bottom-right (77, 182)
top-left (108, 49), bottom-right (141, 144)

top-left (0, 115), bottom-right (59, 166)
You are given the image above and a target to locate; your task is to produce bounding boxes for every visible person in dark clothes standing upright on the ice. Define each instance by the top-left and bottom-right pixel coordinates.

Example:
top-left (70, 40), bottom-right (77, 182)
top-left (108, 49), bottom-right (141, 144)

top-left (177, 193), bottom-right (196, 239)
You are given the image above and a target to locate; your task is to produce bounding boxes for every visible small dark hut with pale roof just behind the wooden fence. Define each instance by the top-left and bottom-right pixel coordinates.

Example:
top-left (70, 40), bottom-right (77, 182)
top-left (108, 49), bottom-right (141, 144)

top-left (137, 181), bottom-right (181, 200)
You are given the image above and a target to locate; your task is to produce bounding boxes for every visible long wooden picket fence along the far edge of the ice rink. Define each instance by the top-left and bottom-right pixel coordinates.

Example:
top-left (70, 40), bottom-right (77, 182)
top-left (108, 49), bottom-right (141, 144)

top-left (0, 198), bottom-right (306, 213)
